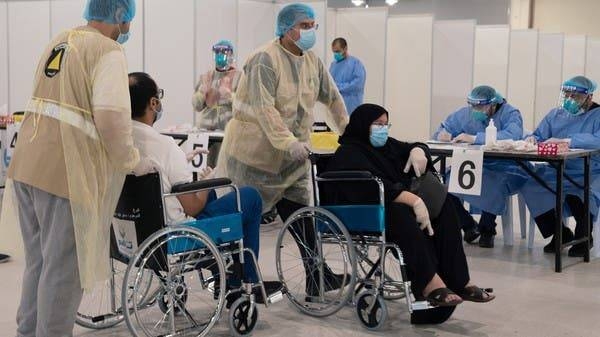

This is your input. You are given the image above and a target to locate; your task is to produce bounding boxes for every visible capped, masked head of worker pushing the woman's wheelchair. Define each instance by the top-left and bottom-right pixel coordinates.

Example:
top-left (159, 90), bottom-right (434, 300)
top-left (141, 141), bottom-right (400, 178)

top-left (275, 4), bottom-right (319, 54)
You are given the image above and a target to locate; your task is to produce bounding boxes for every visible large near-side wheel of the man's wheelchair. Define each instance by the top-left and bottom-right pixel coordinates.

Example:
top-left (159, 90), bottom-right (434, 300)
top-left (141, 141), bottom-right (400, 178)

top-left (123, 226), bottom-right (226, 337)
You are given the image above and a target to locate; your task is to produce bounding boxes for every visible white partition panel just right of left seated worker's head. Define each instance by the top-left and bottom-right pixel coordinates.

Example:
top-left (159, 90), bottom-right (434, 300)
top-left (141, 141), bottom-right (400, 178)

top-left (506, 30), bottom-right (538, 130)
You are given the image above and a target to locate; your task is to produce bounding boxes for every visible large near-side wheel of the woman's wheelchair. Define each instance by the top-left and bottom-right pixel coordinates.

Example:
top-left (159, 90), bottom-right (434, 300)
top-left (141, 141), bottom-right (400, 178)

top-left (275, 207), bottom-right (356, 317)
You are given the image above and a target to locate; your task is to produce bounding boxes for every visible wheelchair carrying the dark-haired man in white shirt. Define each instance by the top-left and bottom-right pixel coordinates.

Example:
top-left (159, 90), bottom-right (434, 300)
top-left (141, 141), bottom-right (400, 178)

top-left (78, 173), bottom-right (282, 337)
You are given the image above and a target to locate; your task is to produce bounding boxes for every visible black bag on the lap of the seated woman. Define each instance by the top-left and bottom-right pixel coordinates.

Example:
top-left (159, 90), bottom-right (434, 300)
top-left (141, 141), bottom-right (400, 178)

top-left (410, 171), bottom-right (448, 219)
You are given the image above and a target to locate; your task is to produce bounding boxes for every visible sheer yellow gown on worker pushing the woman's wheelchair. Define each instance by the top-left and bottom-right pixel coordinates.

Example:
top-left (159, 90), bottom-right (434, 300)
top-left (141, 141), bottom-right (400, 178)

top-left (217, 39), bottom-right (348, 211)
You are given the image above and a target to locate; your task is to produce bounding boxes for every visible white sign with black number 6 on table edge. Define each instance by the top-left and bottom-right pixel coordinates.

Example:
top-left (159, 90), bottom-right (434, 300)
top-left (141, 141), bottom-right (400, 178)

top-left (448, 149), bottom-right (483, 195)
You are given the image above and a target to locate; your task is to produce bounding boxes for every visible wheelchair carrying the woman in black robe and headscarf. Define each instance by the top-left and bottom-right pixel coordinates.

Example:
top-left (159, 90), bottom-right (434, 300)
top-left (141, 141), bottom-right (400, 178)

top-left (276, 155), bottom-right (433, 330)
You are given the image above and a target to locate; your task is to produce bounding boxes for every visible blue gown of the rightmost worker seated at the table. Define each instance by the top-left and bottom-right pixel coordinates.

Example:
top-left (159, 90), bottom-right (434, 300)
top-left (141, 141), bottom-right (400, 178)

top-left (521, 103), bottom-right (600, 217)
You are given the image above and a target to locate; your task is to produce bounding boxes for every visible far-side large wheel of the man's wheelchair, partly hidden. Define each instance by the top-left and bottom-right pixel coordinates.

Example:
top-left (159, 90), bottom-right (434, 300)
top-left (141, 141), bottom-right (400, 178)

top-left (75, 259), bottom-right (152, 330)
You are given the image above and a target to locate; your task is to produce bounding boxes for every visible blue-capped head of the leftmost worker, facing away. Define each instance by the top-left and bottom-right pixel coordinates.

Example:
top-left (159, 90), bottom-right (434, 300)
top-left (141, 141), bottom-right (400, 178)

top-left (83, 0), bottom-right (135, 44)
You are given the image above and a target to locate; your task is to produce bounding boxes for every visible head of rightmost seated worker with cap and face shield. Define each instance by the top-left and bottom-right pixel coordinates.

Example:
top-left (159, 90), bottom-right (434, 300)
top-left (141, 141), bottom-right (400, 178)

top-left (560, 76), bottom-right (597, 116)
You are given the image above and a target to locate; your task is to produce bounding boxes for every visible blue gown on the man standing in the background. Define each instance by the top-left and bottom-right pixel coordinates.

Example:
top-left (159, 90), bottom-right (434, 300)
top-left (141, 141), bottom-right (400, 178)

top-left (329, 55), bottom-right (367, 114)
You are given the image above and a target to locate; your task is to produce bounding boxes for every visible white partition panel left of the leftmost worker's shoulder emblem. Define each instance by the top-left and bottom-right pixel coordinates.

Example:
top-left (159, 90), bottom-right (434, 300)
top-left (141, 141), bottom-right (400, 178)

top-left (7, 1), bottom-right (50, 112)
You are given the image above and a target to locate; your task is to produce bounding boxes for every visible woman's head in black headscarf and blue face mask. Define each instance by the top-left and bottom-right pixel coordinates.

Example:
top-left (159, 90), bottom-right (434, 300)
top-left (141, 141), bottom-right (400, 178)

top-left (340, 104), bottom-right (391, 148)
